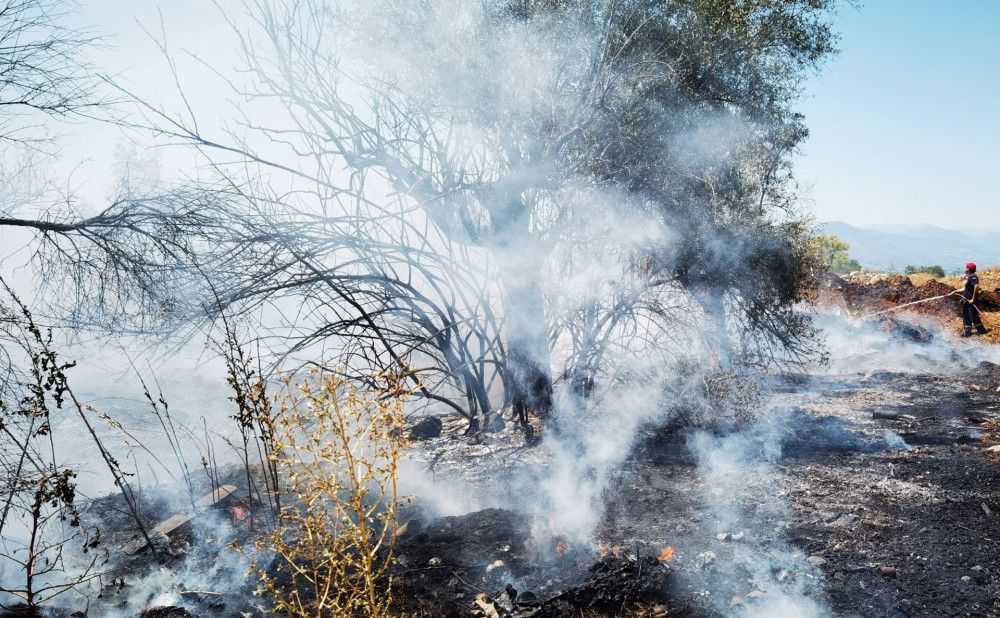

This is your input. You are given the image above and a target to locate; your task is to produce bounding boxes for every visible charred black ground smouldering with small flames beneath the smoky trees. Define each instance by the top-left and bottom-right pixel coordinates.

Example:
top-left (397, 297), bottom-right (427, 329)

top-left (29, 322), bottom-right (1000, 618)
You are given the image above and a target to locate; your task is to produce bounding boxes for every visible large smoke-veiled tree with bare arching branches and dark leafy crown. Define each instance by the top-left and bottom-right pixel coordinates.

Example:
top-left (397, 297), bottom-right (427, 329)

top-left (0, 0), bottom-right (830, 436)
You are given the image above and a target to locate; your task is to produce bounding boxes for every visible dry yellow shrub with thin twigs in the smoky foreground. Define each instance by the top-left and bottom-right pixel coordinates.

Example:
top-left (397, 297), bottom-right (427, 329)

top-left (256, 373), bottom-right (406, 618)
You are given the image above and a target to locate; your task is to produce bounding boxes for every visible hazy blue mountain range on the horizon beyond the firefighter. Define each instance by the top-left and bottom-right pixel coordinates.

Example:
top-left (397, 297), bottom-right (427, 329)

top-left (820, 221), bottom-right (1000, 272)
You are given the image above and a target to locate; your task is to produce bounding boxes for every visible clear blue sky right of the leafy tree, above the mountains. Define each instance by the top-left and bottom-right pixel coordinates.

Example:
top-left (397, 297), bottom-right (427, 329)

top-left (797, 0), bottom-right (1000, 228)
